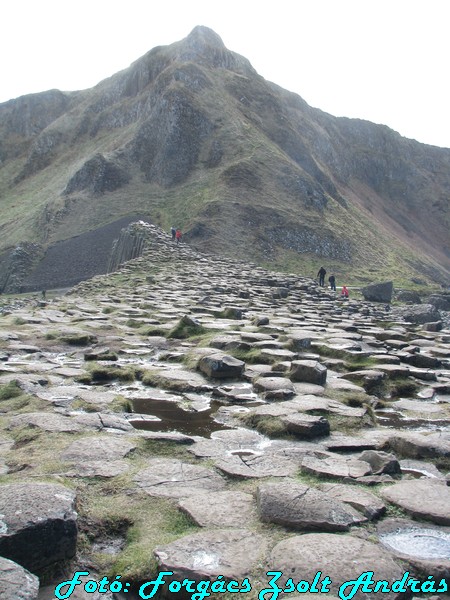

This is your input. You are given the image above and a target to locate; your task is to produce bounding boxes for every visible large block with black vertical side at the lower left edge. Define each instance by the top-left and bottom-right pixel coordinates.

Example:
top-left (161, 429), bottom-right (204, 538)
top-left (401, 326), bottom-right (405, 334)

top-left (0, 482), bottom-right (77, 574)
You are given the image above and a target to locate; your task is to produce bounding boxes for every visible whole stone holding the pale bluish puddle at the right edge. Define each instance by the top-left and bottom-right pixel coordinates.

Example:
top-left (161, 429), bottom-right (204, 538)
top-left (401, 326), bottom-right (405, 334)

top-left (377, 519), bottom-right (450, 581)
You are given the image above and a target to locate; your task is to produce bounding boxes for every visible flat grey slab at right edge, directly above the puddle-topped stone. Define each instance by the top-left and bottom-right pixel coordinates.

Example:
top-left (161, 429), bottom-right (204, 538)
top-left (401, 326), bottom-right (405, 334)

top-left (381, 479), bottom-right (450, 525)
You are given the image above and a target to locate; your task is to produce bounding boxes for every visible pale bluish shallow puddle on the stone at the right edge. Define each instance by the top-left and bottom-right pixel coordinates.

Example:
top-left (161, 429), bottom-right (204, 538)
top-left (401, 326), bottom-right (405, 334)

top-left (380, 528), bottom-right (450, 560)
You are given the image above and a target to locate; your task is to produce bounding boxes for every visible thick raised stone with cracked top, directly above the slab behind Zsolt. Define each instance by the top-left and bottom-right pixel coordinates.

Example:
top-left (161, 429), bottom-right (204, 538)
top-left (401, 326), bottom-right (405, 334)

top-left (257, 481), bottom-right (366, 531)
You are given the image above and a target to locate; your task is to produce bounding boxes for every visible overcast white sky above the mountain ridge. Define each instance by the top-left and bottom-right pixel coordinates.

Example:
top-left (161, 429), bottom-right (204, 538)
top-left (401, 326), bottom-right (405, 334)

top-left (0, 0), bottom-right (450, 147)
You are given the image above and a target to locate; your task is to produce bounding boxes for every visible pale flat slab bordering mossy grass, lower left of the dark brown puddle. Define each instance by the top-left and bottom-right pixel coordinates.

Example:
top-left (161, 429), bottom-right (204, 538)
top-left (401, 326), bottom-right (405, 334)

top-left (61, 435), bottom-right (136, 463)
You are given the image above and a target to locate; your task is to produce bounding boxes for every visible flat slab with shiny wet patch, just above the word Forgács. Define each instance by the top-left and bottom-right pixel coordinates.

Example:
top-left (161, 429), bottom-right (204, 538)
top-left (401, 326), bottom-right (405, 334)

top-left (154, 529), bottom-right (268, 581)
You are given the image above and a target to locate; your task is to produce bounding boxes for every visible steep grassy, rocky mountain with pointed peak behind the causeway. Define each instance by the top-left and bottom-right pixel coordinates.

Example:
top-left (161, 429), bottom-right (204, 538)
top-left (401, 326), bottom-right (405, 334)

top-left (0, 27), bottom-right (450, 292)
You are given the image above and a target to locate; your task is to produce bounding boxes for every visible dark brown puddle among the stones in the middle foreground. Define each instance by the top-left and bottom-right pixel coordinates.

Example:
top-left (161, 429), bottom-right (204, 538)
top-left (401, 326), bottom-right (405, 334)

top-left (131, 399), bottom-right (230, 438)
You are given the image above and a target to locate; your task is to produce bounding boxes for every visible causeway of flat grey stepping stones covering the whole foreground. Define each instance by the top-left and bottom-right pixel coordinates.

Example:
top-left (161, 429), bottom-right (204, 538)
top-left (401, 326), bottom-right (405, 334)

top-left (0, 223), bottom-right (450, 600)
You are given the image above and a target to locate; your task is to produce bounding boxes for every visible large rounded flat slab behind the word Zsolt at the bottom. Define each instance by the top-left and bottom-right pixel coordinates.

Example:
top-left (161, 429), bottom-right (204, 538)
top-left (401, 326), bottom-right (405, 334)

top-left (267, 533), bottom-right (405, 600)
